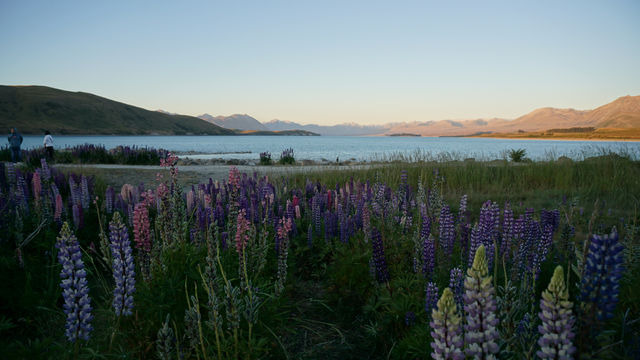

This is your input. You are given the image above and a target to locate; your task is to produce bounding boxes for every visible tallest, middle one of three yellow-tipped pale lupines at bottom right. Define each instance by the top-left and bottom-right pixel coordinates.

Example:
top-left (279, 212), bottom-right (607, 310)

top-left (464, 245), bottom-right (498, 359)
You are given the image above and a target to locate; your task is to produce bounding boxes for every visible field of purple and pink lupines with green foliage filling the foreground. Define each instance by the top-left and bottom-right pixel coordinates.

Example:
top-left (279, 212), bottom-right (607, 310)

top-left (0, 151), bottom-right (640, 359)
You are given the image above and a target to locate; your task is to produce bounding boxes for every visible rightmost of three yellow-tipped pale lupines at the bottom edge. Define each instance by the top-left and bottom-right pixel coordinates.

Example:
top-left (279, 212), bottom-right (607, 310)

top-left (537, 264), bottom-right (576, 360)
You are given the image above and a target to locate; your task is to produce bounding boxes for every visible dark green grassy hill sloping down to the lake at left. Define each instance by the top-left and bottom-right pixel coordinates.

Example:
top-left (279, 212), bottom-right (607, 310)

top-left (0, 85), bottom-right (235, 135)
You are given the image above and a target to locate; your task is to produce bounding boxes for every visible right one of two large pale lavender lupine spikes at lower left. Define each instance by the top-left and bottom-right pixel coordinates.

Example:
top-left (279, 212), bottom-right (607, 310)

top-left (109, 212), bottom-right (136, 316)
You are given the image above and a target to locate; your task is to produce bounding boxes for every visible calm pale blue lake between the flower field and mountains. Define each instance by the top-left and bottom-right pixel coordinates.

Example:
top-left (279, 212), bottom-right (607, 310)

top-left (17, 135), bottom-right (640, 161)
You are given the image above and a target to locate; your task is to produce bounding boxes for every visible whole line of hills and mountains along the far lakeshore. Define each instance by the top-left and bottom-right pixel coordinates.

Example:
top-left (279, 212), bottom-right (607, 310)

top-left (0, 85), bottom-right (640, 136)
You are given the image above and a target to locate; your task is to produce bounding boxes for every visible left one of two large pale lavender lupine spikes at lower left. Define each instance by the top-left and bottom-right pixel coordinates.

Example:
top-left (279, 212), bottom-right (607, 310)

top-left (56, 222), bottom-right (93, 342)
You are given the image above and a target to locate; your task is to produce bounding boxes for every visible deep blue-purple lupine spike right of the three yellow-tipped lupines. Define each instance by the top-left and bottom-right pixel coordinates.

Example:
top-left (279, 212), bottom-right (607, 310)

top-left (580, 229), bottom-right (624, 321)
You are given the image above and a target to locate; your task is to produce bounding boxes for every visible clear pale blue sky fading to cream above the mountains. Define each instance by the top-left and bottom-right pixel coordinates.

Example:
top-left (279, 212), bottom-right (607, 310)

top-left (0, 0), bottom-right (640, 125)
